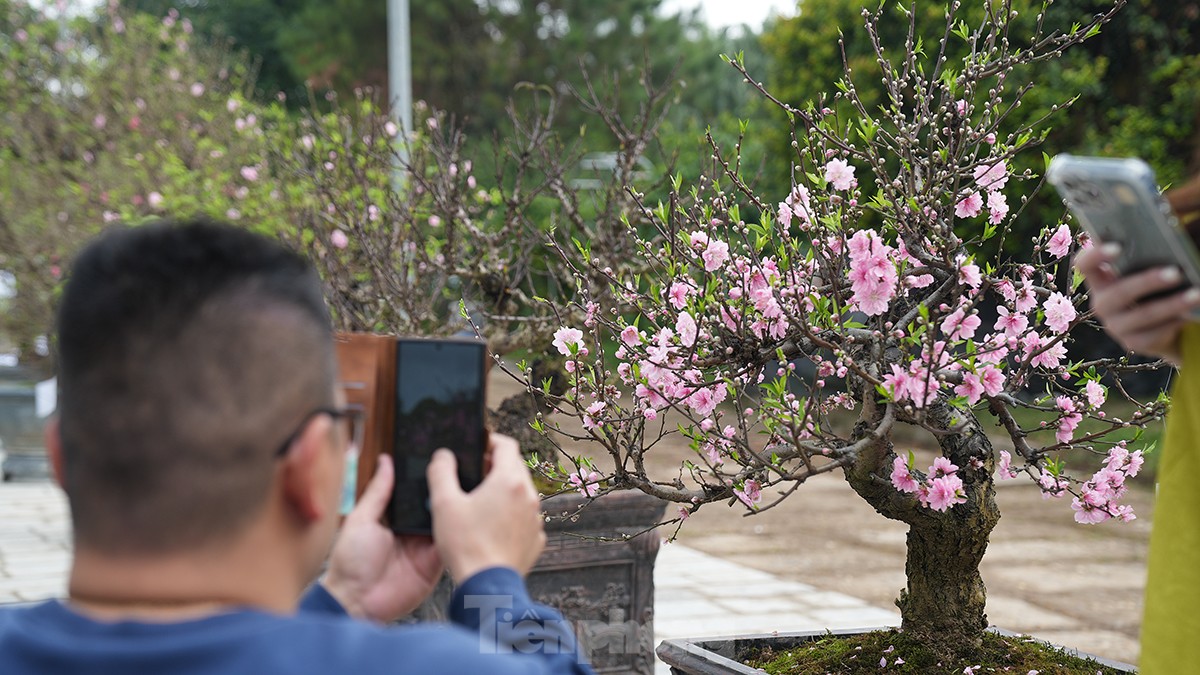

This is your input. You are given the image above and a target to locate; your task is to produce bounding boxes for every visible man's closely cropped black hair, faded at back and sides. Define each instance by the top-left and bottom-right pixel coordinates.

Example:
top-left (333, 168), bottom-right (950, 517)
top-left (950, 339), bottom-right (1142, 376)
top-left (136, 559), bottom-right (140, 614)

top-left (58, 220), bottom-right (335, 552)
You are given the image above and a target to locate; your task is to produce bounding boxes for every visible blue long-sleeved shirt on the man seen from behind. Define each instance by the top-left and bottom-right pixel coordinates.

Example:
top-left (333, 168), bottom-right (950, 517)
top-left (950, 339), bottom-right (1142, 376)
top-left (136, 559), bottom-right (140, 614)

top-left (0, 568), bottom-right (592, 675)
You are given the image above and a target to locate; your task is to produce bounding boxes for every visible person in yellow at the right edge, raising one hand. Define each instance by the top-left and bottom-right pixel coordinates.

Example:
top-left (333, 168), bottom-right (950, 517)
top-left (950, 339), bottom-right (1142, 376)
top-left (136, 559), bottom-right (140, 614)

top-left (1075, 178), bottom-right (1200, 675)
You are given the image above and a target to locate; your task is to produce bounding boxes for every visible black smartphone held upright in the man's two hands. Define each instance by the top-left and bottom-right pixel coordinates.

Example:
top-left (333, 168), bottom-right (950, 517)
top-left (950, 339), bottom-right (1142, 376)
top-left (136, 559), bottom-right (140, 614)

top-left (389, 338), bottom-right (487, 534)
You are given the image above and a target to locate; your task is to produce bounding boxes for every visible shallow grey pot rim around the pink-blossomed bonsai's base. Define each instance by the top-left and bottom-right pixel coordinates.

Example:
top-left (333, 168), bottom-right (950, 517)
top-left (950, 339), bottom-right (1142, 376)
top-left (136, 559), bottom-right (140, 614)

top-left (656, 628), bottom-right (1138, 675)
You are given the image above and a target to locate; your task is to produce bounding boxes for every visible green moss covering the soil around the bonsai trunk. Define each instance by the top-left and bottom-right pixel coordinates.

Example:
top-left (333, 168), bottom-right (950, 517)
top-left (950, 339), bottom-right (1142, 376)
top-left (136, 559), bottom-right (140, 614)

top-left (745, 631), bottom-right (1120, 675)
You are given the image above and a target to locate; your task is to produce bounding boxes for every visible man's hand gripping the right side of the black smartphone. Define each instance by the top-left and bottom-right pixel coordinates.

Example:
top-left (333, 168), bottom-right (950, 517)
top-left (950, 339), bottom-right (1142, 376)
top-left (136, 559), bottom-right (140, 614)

top-left (427, 434), bottom-right (546, 584)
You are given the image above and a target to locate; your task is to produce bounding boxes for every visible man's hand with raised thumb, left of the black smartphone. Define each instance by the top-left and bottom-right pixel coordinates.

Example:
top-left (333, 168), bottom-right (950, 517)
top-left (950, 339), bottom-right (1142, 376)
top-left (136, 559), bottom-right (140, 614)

top-left (324, 454), bottom-right (442, 622)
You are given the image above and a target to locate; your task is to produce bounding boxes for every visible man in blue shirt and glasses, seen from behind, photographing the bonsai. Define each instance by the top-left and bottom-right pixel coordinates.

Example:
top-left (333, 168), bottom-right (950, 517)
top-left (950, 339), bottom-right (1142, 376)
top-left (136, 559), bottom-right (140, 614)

top-left (0, 222), bottom-right (590, 675)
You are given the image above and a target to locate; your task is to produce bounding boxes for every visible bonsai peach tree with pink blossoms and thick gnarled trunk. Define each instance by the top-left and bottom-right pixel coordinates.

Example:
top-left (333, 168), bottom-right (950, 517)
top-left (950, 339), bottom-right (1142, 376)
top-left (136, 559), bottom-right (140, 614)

top-left (514, 0), bottom-right (1165, 651)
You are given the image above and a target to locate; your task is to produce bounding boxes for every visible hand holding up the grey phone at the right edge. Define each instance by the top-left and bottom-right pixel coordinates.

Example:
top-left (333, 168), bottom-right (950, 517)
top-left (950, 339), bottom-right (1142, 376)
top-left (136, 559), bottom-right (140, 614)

top-left (1075, 243), bottom-right (1200, 364)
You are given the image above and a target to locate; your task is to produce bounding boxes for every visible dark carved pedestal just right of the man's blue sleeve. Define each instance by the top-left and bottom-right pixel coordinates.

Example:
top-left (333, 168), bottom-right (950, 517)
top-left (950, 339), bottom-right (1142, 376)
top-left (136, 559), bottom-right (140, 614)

top-left (528, 491), bottom-right (666, 675)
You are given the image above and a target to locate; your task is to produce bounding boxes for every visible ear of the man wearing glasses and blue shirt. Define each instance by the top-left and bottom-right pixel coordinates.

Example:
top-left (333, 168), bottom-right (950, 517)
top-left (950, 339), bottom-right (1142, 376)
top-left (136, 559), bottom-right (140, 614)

top-left (280, 414), bottom-right (334, 522)
